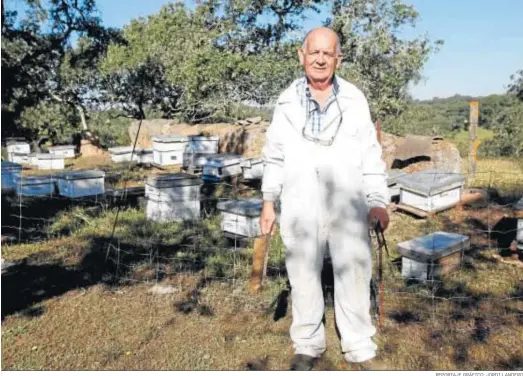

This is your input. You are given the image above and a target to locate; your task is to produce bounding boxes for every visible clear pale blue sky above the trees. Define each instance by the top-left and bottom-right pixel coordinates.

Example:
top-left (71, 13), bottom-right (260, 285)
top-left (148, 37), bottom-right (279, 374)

top-left (8, 0), bottom-right (523, 99)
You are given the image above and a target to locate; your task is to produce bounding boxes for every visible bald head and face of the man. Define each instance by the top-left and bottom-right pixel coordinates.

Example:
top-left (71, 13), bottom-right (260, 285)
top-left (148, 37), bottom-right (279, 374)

top-left (299, 31), bottom-right (341, 82)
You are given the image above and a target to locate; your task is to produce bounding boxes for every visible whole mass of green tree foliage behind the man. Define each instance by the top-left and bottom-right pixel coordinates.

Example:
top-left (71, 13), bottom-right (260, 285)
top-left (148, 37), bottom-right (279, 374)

top-left (2, 0), bottom-right (439, 136)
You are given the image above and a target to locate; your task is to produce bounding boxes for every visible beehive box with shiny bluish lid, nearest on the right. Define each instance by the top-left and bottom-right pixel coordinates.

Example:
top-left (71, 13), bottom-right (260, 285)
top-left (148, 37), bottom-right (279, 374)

top-left (397, 232), bottom-right (470, 280)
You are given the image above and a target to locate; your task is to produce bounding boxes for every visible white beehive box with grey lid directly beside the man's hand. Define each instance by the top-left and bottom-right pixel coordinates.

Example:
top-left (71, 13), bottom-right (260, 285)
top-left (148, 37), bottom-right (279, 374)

top-left (216, 197), bottom-right (263, 238)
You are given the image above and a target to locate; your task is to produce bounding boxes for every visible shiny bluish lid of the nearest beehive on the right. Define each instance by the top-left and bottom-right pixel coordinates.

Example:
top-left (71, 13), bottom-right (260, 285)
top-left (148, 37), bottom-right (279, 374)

top-left (397, 231), bottom-right (470, 261)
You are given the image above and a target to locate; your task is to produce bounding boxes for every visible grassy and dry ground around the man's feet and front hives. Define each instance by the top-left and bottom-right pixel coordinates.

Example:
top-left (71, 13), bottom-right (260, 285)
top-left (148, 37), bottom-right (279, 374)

top-left (2, 160), bottom-right (523, 370)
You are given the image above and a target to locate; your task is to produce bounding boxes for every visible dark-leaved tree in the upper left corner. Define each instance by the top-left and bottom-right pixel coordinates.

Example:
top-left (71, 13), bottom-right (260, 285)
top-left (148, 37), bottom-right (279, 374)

top-left (2, 0), bottom-right (122, 139)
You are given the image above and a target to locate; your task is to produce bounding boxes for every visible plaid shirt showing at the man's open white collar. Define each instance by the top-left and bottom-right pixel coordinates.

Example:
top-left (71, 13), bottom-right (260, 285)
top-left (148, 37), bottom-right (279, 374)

top-left (296, 77), bottom-right (339, 134)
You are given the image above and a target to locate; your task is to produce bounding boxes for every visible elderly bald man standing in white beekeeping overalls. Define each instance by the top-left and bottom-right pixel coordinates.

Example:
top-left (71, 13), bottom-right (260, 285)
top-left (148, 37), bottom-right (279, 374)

top-left (260, 28), bottom-right (389, 370)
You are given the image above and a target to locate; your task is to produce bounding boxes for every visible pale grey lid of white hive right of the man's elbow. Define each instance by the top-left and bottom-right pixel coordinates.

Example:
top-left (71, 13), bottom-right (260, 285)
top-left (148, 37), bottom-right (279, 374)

top-left (396, 169), bottom-right (465, 195)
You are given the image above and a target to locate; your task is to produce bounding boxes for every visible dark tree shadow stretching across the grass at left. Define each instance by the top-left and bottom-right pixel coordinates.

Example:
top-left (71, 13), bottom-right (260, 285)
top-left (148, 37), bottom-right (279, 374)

top-left (2, 216), bottom-right (229, 320)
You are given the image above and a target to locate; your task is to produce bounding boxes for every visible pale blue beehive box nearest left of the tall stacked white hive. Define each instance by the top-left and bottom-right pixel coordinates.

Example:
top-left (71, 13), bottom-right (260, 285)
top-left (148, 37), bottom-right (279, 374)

top-left (56, 170), bottom-right (105, 198)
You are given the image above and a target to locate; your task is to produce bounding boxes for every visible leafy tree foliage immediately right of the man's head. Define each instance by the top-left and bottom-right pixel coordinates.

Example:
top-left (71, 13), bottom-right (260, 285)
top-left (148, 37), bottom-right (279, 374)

top-left (328, 0), bottom-right (443, 119)
